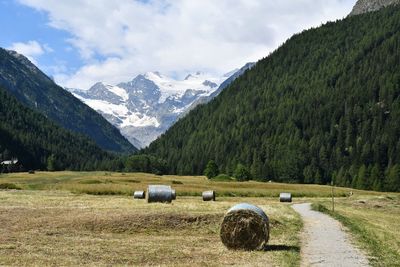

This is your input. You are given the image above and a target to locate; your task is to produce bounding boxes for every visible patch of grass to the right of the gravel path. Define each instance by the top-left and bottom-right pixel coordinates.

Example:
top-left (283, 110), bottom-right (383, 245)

top-left (313, 194), bottom-right (400, 266)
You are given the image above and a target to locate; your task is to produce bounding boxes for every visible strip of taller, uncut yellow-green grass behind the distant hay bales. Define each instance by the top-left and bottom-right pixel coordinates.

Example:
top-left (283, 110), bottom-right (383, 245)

top-left (0, 172), bottom-right (379, 197)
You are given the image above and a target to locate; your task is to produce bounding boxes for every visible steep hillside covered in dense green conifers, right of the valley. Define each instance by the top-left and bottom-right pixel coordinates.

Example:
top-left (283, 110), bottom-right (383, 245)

top-left (143, 7), bottom-right (400, 191)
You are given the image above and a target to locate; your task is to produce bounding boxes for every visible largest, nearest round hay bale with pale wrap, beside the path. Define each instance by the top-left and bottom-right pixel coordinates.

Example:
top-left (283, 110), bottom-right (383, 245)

top-left (220, 203), bottom-right (269, 250)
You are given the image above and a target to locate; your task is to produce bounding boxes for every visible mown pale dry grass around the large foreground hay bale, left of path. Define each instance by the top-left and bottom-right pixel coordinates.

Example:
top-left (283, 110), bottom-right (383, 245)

top-left (0, 192), bottom-right (302, 266)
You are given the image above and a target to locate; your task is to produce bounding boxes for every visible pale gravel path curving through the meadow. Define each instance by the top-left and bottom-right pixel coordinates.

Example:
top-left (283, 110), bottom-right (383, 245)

top-left (293, 203), bottom-right (369, 267)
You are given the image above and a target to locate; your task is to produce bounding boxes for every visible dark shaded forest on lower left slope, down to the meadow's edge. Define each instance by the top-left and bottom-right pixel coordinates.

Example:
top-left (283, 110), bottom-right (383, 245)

top-left (0, 87), bottom-right (166, 174)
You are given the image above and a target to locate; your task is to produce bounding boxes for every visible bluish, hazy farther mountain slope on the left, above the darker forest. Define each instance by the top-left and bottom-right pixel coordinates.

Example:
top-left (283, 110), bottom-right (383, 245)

top-left (0, 48), bottom-right (136, 152)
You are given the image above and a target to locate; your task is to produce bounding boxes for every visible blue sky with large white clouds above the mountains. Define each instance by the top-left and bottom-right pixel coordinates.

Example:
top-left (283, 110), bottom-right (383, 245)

top-left (0, 0), bottom-right (356, 89)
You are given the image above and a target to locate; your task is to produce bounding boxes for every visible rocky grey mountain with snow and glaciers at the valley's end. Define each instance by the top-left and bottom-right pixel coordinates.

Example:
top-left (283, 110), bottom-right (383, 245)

top-left (67, 64), bottom-right (252, 148)
